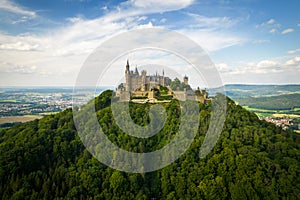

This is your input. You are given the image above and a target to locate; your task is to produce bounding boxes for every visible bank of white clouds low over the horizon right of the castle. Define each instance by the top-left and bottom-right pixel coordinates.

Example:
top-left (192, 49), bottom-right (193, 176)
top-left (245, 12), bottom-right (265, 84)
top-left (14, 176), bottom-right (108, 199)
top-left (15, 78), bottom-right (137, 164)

top-left (216, 57), bottom-right (300, 84)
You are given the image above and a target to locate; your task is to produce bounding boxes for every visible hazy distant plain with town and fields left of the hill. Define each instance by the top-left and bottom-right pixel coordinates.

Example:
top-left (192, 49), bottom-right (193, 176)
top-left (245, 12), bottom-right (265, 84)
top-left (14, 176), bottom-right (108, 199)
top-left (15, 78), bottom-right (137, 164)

top-left (0, 87), bottom-right (94, 128)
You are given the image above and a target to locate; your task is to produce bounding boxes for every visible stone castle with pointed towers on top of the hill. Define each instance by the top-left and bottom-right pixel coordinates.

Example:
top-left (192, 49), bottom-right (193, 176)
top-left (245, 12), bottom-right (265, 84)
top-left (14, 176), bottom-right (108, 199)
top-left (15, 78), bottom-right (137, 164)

top-left (116, 60), bottom-right (209, 103)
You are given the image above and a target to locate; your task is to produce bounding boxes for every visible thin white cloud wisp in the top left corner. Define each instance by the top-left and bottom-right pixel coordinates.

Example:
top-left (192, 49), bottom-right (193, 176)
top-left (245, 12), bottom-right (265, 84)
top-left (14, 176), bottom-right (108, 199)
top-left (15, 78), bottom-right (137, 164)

top-left (0, 0), bottom-right (36, 17)
